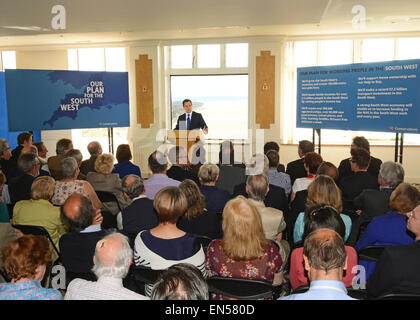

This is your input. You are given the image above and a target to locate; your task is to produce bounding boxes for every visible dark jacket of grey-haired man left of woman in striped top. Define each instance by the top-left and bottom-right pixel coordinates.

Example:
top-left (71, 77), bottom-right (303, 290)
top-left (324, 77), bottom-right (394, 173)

top-left (122, 197), bottom-right (159, 235)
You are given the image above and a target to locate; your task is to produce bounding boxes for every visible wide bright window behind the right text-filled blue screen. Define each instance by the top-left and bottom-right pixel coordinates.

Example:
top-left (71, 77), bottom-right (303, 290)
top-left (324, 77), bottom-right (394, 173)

top-left (283, 38), bottom-right (420, 145)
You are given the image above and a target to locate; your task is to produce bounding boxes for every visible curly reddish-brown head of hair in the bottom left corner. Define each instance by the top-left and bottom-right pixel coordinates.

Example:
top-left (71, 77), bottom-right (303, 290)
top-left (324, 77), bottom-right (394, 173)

top-left (2, 235), bottom-right (51, 282)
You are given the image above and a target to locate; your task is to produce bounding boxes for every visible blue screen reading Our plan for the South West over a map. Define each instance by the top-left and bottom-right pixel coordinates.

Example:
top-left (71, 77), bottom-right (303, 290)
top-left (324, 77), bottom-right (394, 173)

top-left (5, 70), bottom-right (130, 131)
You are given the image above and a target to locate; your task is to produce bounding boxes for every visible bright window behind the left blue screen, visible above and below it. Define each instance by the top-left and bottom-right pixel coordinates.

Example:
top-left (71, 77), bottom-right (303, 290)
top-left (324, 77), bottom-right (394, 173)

top-left (68, 48), bottom-right (128, 159)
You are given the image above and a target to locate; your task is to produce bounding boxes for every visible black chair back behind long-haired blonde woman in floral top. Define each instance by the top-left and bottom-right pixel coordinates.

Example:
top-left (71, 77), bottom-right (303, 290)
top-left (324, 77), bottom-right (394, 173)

top-left (207, 276), bottom-right (274, 300)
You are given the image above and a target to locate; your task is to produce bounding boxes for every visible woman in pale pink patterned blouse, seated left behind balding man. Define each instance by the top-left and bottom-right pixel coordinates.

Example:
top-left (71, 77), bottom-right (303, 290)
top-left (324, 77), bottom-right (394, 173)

top-left (51, 157), bottom-right (102, 209)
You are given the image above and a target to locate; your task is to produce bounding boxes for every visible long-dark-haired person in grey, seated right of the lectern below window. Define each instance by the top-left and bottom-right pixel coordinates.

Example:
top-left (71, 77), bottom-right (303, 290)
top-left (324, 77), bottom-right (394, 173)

top-left (216, 140), bottom-right (246, 194)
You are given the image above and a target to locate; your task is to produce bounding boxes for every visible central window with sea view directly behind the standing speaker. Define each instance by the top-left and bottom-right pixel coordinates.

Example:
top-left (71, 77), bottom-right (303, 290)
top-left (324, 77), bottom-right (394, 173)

top-left (165, 43), bottom-right (249, 140)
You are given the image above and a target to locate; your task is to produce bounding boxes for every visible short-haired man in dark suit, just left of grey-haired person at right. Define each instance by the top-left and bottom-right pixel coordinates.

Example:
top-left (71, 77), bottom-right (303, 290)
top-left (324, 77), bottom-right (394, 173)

top-left (338, 148), bottom-right (378, 215)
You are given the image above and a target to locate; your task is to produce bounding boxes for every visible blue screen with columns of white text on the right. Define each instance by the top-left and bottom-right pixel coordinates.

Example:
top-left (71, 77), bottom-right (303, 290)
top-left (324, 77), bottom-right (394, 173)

top-left (296, 59), bottom-right (420, 133)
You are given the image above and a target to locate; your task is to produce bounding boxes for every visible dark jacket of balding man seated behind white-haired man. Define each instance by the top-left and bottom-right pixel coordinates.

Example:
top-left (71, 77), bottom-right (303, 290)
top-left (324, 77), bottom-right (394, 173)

top-left (59, 230), bottom-right (107, 273)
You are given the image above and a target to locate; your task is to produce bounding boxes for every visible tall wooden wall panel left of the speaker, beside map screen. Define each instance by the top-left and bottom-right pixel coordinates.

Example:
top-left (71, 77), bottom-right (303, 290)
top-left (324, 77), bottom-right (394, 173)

top-left (136, 54), bottom-right (155, 128)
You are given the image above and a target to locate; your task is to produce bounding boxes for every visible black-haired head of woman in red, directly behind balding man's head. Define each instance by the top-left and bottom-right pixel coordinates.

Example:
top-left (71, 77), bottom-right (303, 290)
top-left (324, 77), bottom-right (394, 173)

top-left (302, 204), bottom-right (346, 240)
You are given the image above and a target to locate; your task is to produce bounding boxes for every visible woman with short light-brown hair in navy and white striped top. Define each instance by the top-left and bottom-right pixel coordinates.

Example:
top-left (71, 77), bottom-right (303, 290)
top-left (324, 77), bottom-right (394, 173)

top-left (134, 186), bottom-right (207, 296)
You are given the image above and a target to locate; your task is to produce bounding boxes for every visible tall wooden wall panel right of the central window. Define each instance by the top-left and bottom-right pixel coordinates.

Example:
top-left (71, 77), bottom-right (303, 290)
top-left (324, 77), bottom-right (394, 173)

top-left (255, 51), bottom-right (275, 129)
